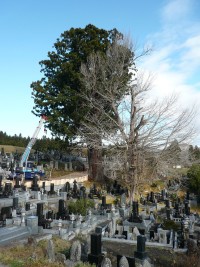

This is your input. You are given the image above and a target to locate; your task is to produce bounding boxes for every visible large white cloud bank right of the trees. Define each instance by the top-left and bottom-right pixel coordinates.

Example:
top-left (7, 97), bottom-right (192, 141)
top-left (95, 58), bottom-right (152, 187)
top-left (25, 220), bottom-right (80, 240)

top-left (141, 0), bottom-right (200, 146)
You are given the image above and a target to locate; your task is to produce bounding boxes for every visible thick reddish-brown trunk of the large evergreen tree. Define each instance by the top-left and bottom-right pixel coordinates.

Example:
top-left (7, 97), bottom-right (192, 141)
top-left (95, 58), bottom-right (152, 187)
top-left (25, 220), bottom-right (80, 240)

top-left (88, 147), bottom-right (103, 181)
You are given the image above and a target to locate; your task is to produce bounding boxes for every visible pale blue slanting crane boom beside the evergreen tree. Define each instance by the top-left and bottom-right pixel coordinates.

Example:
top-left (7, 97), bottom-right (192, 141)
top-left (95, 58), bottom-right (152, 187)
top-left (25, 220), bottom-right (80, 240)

top-left (19, 116), bottom-right (46, 167)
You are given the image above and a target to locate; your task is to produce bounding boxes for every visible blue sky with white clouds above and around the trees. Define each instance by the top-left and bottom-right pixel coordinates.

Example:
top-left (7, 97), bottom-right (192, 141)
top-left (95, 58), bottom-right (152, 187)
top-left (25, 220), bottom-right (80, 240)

top-left (0, 0), bottom-right (200, 145)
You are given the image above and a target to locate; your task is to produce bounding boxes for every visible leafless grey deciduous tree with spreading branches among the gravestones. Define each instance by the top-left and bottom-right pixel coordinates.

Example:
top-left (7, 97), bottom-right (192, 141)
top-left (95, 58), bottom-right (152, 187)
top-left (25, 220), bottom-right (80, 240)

top-left (77, 38), bottom-right (195, 200)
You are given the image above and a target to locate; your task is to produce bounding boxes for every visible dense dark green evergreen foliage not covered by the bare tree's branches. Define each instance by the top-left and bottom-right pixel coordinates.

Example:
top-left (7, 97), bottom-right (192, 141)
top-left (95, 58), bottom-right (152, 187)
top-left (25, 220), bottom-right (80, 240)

top-left (31, 24), bottom-right (122, 179)
